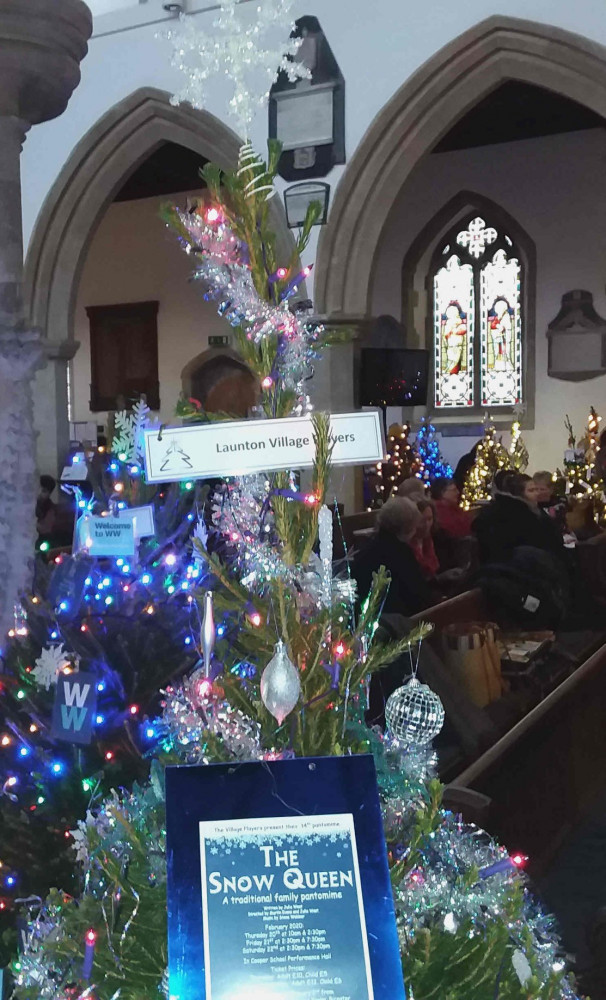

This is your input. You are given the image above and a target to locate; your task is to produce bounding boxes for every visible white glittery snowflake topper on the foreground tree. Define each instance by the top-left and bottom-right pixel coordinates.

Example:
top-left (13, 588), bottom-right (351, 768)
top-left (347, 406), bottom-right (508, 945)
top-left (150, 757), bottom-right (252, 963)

top-left (168, 0), bottom-right (311, 138)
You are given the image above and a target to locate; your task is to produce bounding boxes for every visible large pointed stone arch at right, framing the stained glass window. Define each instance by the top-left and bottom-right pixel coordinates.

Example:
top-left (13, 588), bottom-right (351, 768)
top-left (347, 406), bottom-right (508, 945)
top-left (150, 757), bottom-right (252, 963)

top-left (315, 15), bottom-right (606, 319)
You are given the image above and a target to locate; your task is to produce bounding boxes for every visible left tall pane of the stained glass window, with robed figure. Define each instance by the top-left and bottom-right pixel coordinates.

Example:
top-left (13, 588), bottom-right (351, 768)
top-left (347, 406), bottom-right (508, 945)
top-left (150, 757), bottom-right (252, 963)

top-left (434, 255), bottom-right (475, 407)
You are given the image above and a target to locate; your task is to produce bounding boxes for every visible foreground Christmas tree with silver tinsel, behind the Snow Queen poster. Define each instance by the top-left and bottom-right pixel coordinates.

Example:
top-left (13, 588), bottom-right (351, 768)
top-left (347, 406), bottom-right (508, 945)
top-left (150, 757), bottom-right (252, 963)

top-left (8, 141), bottom-right (574, 1000)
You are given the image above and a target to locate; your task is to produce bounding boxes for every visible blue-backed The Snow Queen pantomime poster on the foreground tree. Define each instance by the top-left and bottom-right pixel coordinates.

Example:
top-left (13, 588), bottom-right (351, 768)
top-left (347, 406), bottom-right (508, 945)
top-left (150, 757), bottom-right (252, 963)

top-left (166, 756), bottom-right (405, 1000)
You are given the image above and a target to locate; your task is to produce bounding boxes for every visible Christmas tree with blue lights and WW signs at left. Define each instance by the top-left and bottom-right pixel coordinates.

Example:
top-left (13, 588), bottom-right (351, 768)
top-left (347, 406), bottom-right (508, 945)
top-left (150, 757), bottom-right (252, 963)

top-left (0, 414), bottom-right (205, 957)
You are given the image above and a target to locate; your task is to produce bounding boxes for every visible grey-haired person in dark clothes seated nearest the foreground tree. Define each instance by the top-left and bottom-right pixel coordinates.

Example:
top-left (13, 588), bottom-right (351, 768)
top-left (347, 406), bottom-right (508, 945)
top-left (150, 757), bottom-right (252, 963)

top-left (351, 497), bottom-right (435, 615)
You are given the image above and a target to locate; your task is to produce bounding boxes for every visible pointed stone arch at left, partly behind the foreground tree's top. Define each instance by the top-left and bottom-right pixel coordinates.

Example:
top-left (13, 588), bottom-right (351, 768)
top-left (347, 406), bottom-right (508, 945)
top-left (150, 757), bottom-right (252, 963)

top-left (24, 87), bottom-right (293, 343)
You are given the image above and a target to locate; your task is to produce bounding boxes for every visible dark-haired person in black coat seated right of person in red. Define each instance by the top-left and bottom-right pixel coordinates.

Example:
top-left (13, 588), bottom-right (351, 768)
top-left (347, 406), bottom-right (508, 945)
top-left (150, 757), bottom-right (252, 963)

top-left (473, 472), bottom-right (564, 563)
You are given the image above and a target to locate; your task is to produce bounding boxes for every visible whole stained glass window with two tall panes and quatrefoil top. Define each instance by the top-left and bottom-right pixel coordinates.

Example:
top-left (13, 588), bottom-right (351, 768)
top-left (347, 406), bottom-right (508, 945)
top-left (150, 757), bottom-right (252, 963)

top-left (433, 215), bottom-right (523, 409)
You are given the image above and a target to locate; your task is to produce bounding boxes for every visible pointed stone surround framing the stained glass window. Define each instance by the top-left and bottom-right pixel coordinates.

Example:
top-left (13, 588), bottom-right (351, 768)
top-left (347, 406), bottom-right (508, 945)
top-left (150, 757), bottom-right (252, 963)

top-left (402, 191), bottom-right (537, 428)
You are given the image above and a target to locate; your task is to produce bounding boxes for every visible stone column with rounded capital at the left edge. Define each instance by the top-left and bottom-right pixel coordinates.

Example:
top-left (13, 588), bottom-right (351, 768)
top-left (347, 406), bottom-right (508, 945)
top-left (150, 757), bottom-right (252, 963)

top-left (0, 0), bottom-right (92, 643)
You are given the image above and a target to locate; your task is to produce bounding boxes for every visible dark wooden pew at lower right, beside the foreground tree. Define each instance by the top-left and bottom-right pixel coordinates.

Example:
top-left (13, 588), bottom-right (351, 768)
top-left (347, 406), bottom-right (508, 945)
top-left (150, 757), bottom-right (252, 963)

top-left (446, 645), bottom-right (606, 875)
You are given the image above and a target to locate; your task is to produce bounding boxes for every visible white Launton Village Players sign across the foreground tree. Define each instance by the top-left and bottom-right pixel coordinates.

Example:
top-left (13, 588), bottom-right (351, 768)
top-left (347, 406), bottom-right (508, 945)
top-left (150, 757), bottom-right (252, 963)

top-left (144, 410), bottom-right (384, 483)
